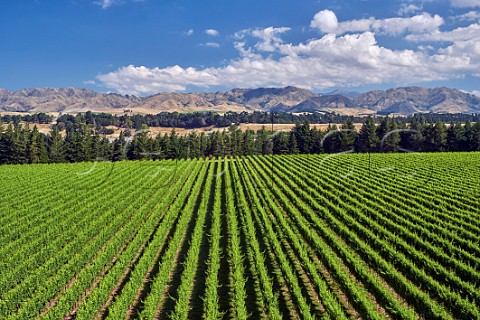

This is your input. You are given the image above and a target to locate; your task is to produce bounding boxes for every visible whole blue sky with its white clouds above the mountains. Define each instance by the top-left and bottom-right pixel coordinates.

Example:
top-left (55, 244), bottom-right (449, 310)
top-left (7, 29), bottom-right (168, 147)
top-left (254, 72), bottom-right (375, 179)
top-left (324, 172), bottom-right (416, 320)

top-left (0, 0), bottom-right (480, 95)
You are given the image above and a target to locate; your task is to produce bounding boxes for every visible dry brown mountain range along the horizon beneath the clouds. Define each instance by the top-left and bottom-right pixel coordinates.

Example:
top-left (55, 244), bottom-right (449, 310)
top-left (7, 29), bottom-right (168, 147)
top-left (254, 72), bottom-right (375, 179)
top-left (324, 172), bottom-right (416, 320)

top-left (0, 87), bottom-right (480, 115)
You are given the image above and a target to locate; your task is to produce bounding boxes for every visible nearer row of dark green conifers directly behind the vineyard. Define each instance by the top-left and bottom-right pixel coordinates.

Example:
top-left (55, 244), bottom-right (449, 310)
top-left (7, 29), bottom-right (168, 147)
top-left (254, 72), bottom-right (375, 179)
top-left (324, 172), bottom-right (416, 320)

top-left (0, 116), bottom-right (480, 164)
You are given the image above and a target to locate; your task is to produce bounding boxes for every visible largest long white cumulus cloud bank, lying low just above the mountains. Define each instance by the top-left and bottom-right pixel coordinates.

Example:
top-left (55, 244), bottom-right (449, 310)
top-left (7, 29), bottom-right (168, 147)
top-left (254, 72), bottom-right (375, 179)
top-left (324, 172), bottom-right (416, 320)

top-left (98, 32), bottom-right (480, 95)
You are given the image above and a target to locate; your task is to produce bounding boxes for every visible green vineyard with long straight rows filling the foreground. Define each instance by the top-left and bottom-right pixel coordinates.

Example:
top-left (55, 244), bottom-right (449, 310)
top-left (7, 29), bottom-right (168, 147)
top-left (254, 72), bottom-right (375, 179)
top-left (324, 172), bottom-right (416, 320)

top-left (0, 153), bottom-right (480, 320)
